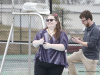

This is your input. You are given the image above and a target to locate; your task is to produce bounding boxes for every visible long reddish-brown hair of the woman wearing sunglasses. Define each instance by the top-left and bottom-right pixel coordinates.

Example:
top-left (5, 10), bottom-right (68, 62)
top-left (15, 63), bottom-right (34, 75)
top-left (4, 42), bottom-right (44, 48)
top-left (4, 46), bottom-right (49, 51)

top-left (45, 14), bottom-right (61, 41)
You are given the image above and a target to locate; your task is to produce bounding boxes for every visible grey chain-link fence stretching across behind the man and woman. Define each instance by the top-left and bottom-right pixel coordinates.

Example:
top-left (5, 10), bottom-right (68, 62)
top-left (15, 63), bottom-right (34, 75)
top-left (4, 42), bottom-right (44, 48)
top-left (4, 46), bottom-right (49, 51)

top-left (0, 0), bottom-right (100, 75)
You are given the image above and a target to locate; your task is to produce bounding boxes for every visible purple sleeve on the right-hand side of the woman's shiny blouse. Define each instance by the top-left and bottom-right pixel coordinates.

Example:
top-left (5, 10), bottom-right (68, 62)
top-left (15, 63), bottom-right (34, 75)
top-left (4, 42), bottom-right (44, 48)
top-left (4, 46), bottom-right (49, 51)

top-left (60, 32), bottom-right (68, 50)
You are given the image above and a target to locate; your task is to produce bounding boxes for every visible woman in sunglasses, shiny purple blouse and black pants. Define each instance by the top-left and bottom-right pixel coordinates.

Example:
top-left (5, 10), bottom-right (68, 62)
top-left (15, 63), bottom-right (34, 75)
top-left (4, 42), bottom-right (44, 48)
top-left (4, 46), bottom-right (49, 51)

top-left (33, 14), bottom-right (68, 75)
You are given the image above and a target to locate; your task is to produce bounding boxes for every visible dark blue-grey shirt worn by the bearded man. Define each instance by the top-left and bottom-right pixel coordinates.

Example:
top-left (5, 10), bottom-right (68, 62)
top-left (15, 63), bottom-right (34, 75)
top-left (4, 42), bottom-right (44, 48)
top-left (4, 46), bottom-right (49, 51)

top-left (82, 23), bottom-right (100, 60)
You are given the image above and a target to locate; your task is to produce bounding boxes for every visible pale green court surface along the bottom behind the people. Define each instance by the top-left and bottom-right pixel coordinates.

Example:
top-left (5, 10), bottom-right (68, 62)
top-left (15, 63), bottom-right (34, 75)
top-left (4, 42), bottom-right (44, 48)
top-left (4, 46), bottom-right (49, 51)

top-left (0, 54), bottom-right (100, 75)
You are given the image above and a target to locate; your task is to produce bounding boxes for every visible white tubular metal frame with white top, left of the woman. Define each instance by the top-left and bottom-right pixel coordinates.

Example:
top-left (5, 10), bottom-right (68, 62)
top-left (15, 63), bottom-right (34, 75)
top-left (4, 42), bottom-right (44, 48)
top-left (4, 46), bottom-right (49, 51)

top-left (0, 0), bottom-right (50, 75)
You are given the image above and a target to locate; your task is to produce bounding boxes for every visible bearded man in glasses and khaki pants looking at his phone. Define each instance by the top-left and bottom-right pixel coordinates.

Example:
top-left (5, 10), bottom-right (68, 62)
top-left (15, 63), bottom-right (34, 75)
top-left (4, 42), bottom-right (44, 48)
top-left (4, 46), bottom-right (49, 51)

top-left (67, 10), bottom-right (100, 75)
